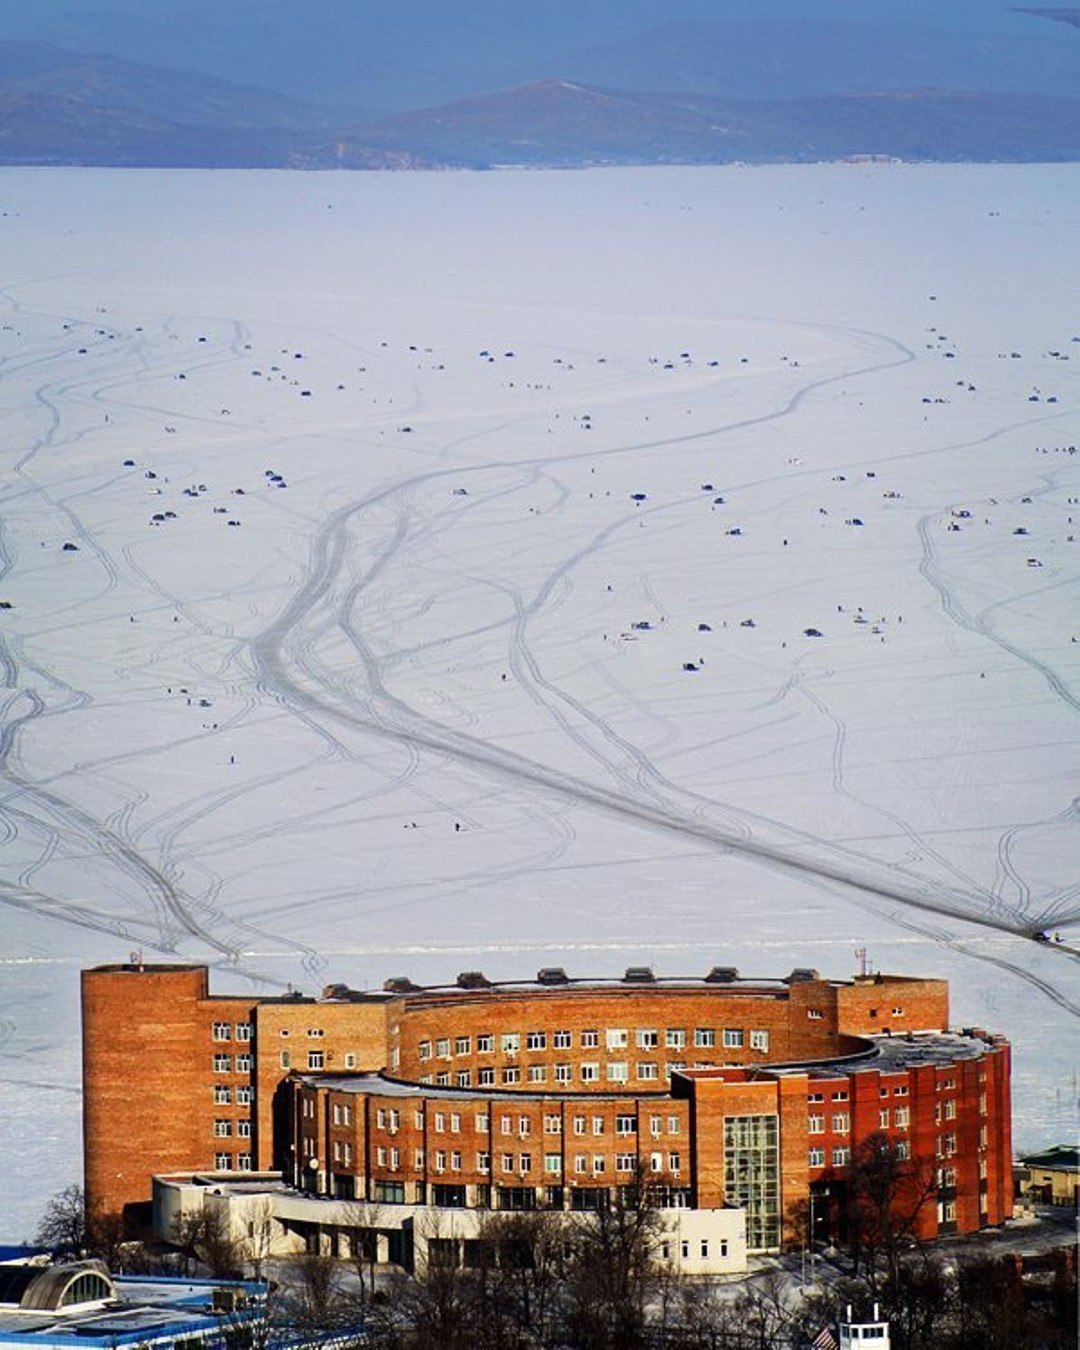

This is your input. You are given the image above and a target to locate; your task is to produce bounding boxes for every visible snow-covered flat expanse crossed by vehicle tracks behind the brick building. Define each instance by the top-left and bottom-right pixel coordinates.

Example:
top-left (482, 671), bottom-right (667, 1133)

top-left (0, 166), bottom-right (1080, 1238)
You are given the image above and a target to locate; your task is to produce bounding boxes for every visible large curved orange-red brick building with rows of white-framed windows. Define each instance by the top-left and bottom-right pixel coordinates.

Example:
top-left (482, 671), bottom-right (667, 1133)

top-left (82, 965), bottom-right (1013, 1250)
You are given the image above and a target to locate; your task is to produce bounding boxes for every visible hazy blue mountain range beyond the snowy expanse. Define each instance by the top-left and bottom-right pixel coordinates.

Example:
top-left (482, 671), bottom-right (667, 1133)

top-left (0, 0), bottom-right (1080, 169)
